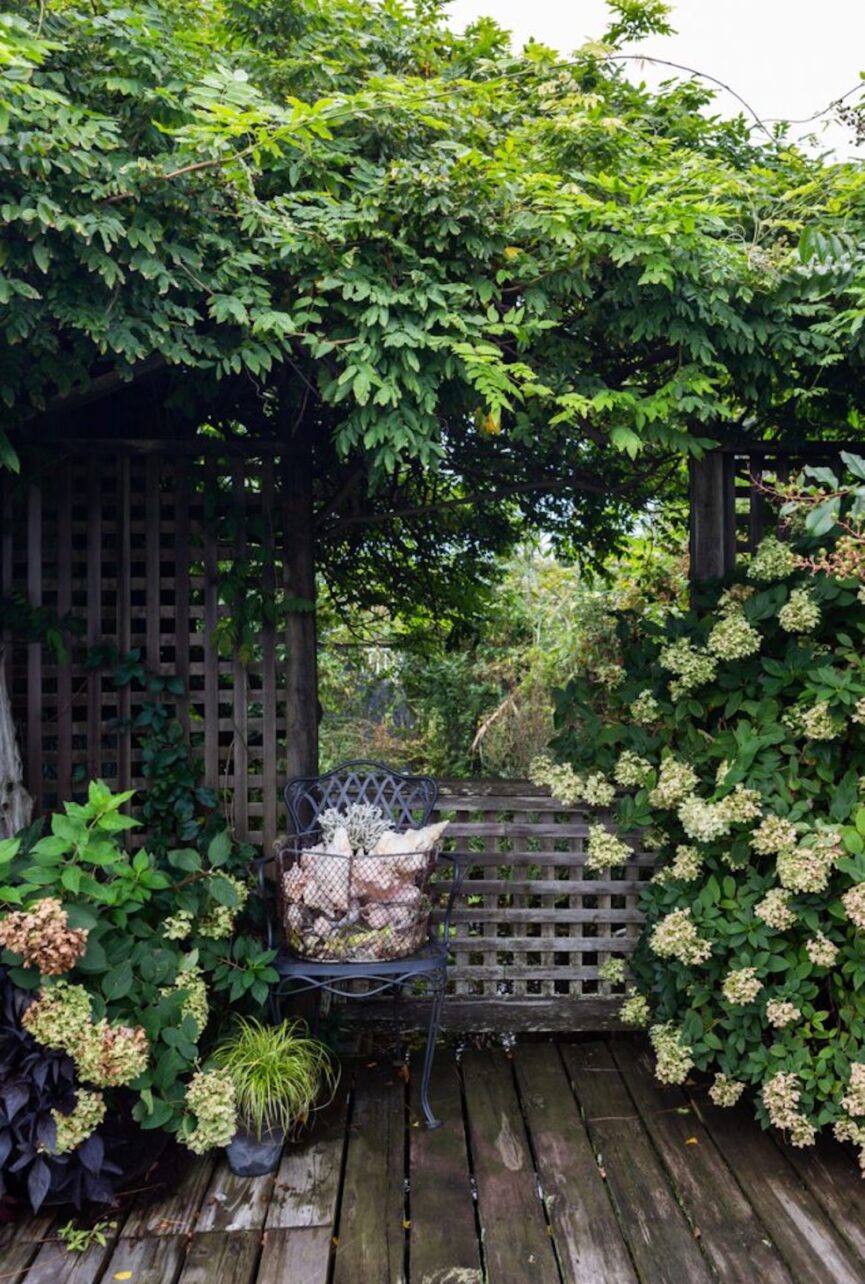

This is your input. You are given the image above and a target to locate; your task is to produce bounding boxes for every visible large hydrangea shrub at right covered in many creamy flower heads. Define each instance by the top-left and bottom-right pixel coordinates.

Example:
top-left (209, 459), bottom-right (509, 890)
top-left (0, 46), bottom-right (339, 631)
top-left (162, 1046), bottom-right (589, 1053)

top-left (535, 485), bottom-right (865, 1166)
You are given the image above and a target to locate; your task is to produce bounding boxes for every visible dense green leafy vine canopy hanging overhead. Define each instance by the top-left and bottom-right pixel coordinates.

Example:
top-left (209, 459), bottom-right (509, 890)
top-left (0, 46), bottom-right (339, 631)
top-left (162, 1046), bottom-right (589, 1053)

top-left (0, 0), bottom-right (865, 613)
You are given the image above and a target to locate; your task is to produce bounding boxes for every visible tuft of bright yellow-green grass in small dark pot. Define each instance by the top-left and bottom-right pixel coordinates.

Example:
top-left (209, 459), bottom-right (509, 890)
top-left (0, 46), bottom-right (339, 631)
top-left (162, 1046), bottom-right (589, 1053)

top-left (212, 1017), bottom-right (339, 1140)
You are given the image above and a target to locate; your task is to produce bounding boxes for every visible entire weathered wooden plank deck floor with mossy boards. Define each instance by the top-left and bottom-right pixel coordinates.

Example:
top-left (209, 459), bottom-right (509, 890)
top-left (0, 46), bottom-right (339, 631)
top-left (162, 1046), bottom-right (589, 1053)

top-left (0, 1037), bottom-right (865, 1284)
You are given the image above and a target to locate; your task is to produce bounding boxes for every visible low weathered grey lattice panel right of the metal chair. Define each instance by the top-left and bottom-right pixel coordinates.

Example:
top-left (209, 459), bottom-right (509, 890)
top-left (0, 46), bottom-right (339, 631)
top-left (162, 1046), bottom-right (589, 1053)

top-left (438, 781), bottom-right (655, 1028)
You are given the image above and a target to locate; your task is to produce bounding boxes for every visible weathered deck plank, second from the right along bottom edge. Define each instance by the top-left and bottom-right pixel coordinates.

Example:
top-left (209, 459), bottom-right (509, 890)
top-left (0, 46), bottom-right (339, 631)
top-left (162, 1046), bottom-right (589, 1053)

top-left (611, 1040), bottom-right (791, 1284)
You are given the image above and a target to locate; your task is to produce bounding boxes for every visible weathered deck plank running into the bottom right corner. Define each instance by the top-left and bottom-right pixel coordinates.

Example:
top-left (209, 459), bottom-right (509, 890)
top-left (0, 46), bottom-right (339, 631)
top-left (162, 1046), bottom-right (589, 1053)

top-left (692, 1094), bottom-right (865, 1284)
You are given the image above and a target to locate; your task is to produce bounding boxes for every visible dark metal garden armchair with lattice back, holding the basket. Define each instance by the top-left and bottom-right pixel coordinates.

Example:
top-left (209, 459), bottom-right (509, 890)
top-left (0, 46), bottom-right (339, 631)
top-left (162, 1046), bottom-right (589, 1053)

top-left (259, 760), bottom-right (466, 1129)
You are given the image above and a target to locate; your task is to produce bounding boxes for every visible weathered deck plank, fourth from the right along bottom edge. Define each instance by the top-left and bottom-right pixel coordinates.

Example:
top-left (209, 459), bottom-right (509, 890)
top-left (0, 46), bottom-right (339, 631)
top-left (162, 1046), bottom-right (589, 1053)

top-left (513, 1044), bottom-right (637, 1284)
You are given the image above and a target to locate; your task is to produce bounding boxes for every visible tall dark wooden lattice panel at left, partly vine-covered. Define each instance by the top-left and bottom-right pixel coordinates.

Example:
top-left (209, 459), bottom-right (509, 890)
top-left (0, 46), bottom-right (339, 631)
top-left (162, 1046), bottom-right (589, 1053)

top-left (0, 451), bottom-right (285, 845)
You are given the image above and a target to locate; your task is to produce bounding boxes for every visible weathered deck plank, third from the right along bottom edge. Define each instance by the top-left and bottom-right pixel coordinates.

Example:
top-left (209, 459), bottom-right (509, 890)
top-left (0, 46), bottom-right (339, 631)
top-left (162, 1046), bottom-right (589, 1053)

top-left (562, 1043), bottom-right (712, 1284)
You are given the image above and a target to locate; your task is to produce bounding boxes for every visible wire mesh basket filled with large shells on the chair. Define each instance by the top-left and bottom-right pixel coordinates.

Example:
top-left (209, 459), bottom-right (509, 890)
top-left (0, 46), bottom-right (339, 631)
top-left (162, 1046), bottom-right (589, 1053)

top-left (276, 838), bottom-right (438, 963)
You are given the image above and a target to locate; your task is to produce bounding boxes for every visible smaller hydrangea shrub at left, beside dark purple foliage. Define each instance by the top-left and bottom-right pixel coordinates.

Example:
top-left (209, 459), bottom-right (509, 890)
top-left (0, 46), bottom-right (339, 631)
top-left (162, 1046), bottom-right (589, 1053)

top-left (0, 781), bottom-right (277, 1171)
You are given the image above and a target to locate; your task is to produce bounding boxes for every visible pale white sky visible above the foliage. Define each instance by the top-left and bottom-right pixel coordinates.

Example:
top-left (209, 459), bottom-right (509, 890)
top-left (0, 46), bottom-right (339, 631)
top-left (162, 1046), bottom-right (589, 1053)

top-left (450, 0), bottom-right (865, 155)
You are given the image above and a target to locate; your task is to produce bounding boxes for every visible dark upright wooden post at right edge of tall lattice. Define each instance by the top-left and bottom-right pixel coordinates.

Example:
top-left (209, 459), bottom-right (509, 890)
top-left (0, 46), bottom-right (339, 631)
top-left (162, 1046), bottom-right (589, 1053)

top-left (282, 421), bottom-right (318, 778)
